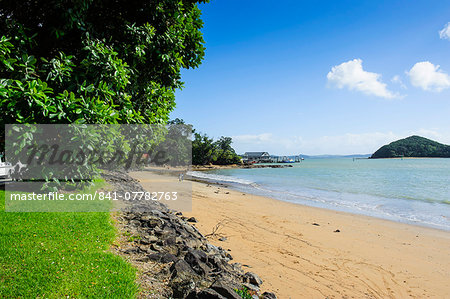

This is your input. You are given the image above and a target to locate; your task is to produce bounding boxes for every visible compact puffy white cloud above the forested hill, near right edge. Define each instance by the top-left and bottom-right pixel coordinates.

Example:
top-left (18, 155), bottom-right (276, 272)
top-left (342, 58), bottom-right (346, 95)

top-left (407, 61), bottom-right (450, 92)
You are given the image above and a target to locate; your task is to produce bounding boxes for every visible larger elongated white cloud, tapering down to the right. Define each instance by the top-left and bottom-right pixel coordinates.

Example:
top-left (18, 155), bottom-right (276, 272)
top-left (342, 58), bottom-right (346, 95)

top-left (327, 59), bottom-right (399, 99)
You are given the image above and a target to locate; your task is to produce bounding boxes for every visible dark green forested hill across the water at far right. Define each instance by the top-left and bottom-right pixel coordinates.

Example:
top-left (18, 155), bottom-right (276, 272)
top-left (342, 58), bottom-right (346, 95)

top-left (370, 136), bottom-right (450, 159)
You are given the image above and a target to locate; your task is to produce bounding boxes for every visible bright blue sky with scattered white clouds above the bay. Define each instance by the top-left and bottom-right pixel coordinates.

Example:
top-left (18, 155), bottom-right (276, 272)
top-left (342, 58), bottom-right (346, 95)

top-left (171, 0), bottom-right (450, 155)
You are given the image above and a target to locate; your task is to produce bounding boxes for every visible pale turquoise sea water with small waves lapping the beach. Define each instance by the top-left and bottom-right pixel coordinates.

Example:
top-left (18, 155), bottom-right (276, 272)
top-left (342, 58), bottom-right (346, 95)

top-left (191, 159), bottom-right (450, 230)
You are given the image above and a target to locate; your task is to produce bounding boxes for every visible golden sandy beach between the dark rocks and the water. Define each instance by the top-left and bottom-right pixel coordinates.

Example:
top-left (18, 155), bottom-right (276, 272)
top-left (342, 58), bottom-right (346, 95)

top-left (131, 172), bottom-right (450, 298)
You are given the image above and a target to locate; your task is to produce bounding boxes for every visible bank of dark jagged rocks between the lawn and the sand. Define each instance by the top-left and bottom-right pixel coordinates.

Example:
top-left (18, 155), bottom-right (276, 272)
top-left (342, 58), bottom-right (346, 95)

top-left (103, 172), bottom-right (276, 298)
